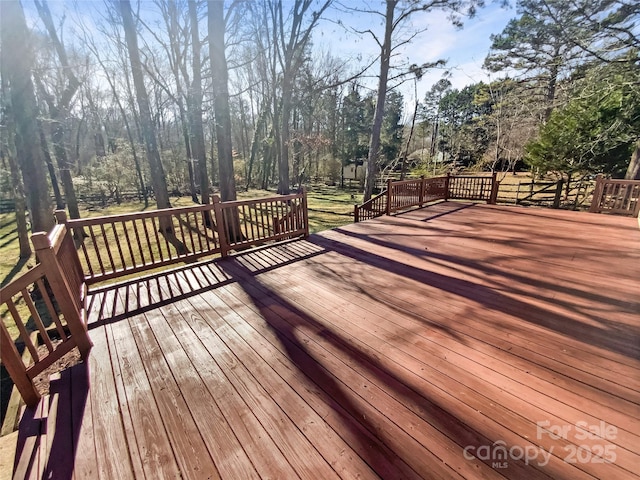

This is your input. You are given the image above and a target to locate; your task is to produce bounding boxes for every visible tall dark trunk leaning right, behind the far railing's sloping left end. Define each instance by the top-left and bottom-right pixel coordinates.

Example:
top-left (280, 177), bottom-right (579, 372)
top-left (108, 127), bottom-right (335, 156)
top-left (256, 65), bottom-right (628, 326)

top-left (363, 0), bottom-right (398, 202)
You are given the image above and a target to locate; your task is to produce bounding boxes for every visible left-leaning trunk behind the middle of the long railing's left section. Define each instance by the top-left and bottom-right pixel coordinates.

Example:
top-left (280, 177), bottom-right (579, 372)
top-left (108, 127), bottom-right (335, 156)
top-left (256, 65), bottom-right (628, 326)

top-left (119, 0), bottom-right (173, 233)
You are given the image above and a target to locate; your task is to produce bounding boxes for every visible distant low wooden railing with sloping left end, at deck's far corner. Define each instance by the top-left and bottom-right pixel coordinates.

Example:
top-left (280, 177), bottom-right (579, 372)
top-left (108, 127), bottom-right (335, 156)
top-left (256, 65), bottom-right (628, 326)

top-left (354, 174), bottom-right (499, 222)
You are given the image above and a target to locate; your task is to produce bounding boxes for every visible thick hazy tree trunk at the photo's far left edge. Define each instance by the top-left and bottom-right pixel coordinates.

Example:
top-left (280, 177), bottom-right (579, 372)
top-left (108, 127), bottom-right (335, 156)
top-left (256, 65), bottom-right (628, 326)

top-left (0, 0), bottom-right (54, 232)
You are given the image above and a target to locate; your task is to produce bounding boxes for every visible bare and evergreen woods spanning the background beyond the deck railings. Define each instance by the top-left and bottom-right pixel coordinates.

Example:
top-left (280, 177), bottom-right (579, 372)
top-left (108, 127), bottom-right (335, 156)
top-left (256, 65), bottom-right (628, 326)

top-left (0, 0), bottom-right (640, 244)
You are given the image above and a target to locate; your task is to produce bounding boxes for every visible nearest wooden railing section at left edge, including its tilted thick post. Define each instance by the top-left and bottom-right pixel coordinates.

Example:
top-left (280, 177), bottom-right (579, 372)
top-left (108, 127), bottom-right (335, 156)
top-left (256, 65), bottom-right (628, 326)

top-left (0, 225), bottom-right (92, 407)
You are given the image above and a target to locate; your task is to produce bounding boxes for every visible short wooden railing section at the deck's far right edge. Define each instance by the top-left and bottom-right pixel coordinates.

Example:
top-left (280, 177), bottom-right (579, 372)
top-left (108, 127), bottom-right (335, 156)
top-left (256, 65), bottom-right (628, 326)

top-left (589, 175), bottom-right (640, 217)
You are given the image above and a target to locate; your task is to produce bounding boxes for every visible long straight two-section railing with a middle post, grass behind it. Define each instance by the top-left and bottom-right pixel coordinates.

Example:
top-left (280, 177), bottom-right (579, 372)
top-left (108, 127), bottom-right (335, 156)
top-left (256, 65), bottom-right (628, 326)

top-left (58, 193), bottom-right (309, 284)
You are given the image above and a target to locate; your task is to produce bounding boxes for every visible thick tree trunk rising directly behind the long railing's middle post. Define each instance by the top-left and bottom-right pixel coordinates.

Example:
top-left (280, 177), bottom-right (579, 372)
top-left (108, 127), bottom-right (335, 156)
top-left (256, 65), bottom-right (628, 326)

top-left (208, 0), bottom-right (236, 202)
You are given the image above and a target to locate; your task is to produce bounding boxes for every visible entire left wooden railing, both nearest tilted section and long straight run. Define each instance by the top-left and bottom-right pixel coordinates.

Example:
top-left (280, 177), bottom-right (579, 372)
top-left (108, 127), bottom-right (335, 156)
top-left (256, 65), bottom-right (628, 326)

top-left (0, 192), bottom-right (309, 407)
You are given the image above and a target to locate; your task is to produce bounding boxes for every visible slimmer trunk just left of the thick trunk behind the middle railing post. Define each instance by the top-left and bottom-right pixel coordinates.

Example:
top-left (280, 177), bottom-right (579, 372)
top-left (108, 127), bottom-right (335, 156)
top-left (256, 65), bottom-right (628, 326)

top-left (189, 0), bottom-right (209, 204)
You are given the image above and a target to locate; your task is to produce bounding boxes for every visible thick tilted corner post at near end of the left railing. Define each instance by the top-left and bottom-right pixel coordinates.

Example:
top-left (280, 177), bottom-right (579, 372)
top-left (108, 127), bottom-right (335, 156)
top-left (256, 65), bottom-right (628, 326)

top-left (31, 232), bottom-right (93, 358)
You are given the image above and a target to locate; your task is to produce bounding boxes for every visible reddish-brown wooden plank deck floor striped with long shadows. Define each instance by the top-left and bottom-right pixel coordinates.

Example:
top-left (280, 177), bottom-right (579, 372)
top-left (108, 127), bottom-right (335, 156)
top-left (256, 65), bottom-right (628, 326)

top-left (11, 202), bottom-right (640, 480)
